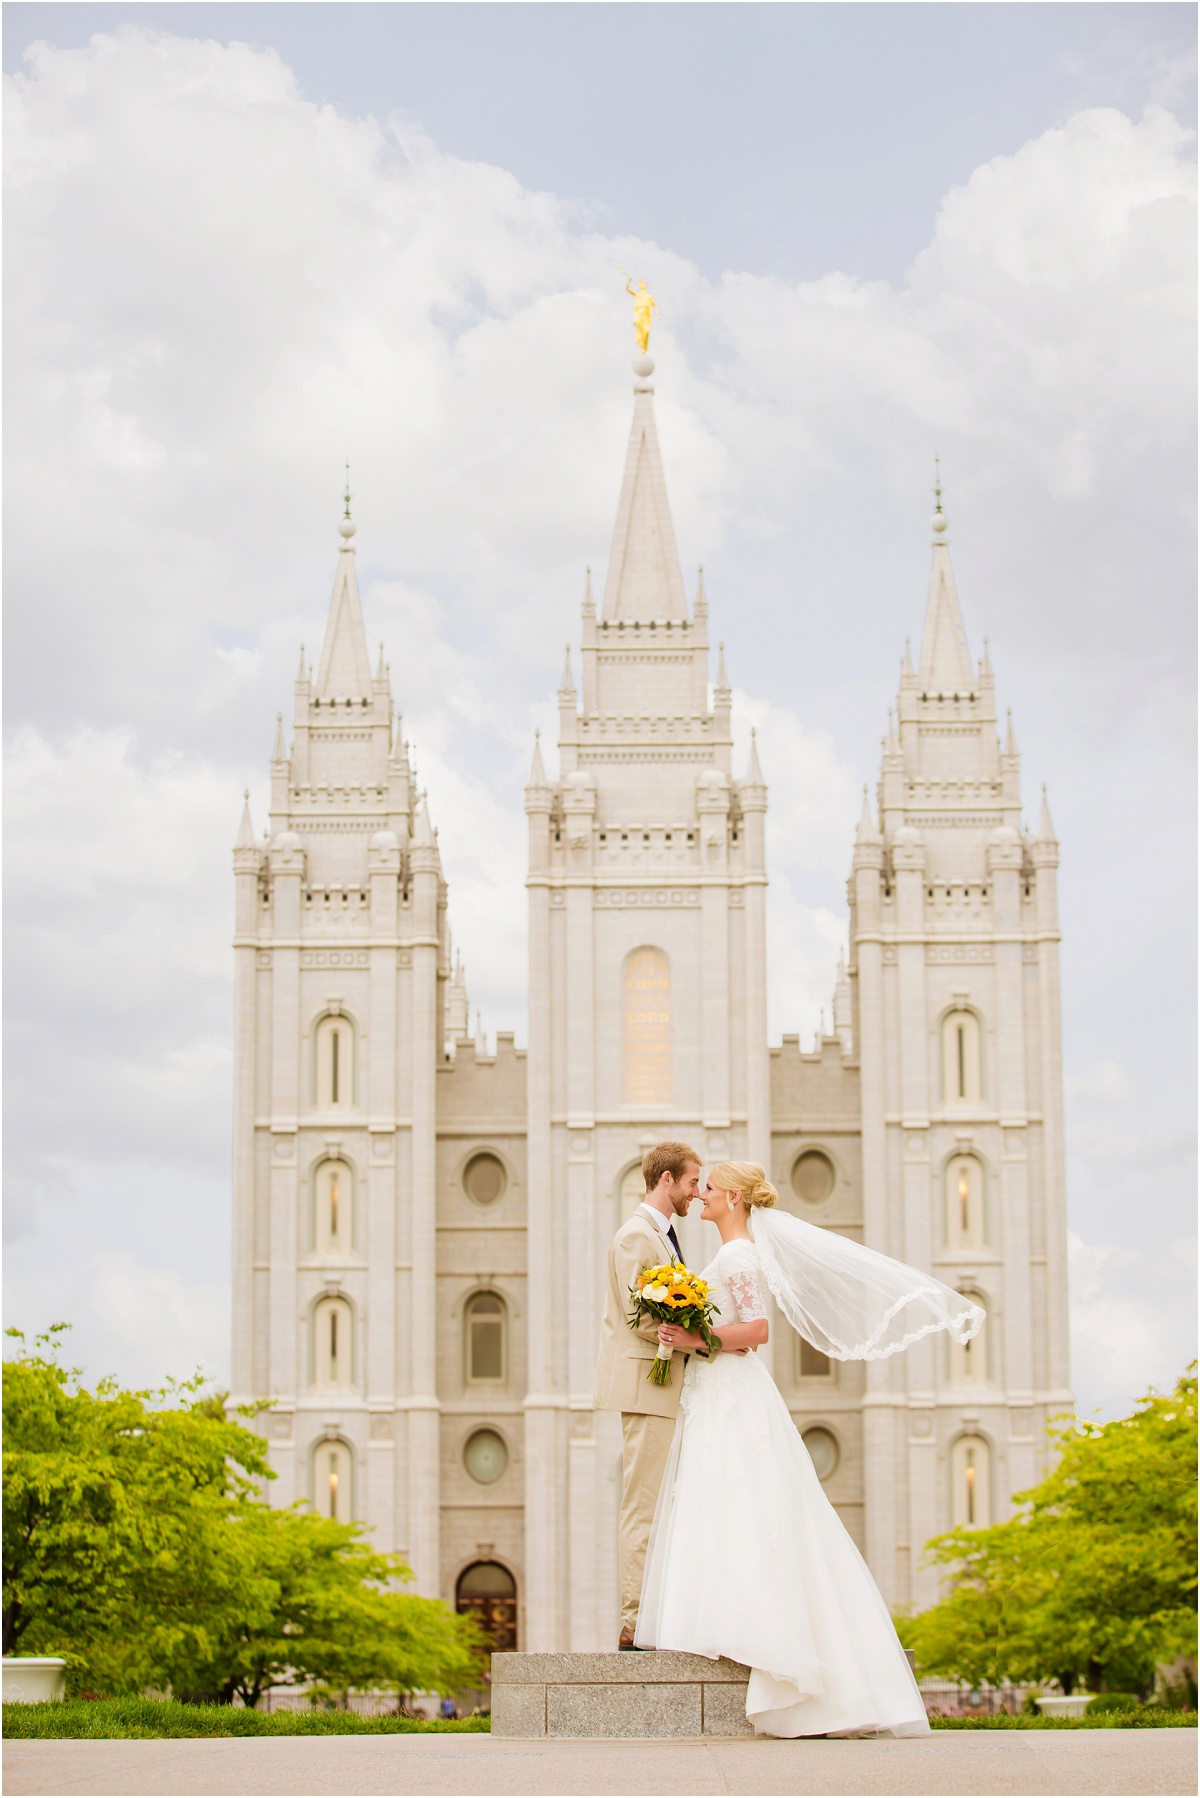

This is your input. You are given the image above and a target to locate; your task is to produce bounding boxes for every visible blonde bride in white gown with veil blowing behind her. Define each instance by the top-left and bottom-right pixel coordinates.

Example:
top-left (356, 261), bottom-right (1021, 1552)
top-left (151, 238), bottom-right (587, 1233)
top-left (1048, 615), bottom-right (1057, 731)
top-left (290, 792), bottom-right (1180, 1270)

top-left (635, 1162), bottom-right (984, 1735)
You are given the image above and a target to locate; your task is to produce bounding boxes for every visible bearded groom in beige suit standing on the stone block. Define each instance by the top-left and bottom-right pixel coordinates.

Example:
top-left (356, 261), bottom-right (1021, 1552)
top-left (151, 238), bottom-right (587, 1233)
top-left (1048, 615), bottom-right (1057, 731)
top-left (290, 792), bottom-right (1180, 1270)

top-left (596, 1142), bottom-right (700, 1649)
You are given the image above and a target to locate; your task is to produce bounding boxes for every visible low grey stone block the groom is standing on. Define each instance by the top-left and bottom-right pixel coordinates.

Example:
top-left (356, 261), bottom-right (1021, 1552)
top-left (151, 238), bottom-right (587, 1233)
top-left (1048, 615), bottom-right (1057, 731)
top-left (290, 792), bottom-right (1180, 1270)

top-left (491, 1649), bottom-right (754, 1737)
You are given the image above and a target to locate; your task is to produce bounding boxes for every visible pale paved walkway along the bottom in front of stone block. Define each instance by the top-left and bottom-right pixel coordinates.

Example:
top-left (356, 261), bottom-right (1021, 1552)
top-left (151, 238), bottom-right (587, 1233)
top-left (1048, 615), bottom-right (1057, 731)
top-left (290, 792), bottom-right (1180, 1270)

top-left (4, 1730), bottom-right (1196, 1798)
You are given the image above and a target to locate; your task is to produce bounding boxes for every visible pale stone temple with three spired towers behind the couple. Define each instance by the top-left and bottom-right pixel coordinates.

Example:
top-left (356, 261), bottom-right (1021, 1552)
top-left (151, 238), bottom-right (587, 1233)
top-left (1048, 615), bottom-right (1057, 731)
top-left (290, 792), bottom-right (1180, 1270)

top-left (234, 360), bottom-right (1070, 1651)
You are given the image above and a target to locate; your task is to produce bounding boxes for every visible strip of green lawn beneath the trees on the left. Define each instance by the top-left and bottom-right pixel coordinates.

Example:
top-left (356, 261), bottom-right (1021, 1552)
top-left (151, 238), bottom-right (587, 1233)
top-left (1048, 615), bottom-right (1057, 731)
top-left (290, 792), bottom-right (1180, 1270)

top-left (4, 1697), bottom-right (491, 1740)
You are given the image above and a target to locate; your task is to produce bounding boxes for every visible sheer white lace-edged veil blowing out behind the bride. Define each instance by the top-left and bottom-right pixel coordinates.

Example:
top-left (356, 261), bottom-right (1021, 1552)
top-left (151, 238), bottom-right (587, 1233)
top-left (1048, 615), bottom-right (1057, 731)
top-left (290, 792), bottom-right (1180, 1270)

top-left (747, 1206), bottom-right (984, 1361)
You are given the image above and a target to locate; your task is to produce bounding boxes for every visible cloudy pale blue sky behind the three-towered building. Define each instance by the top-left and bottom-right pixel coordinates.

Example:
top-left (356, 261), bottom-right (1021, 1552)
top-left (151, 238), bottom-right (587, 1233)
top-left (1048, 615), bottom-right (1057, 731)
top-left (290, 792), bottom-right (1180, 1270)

top-left (4, 0), bottom-right (1195, 1415)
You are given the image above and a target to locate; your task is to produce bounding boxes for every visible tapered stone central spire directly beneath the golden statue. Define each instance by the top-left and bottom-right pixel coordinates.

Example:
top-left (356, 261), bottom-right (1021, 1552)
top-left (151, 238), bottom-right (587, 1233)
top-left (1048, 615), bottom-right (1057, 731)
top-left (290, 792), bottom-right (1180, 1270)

top-left (601, 356), bottom-right (687, 624)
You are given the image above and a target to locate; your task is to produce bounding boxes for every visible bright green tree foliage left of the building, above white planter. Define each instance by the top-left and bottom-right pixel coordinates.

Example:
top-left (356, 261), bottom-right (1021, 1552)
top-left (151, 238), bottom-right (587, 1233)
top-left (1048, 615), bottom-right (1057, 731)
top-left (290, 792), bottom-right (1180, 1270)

top-left (4, 1327), bottom-right (480, 1705)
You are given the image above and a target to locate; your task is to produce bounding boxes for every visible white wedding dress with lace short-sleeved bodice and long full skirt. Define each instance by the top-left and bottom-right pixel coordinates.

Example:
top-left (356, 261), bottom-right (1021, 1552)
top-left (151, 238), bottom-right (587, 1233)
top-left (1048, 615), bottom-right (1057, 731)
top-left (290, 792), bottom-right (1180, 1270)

top-left (637, 1241), bottom-right (928, 1735)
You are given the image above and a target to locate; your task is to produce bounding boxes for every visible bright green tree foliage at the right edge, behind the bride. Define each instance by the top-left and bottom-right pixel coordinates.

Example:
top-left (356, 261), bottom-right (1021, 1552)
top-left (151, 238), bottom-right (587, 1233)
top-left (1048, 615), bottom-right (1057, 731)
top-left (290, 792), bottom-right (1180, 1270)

top-left (903, 1368), bottom-right (1196, 1692)
